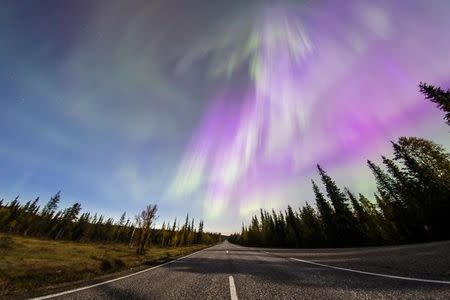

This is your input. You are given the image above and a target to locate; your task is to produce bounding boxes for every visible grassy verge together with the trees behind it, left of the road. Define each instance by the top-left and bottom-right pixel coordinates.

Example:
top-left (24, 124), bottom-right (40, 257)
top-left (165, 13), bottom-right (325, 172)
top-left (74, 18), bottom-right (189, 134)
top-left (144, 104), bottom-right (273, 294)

top-left (0, 192), bottom-right (222, 297)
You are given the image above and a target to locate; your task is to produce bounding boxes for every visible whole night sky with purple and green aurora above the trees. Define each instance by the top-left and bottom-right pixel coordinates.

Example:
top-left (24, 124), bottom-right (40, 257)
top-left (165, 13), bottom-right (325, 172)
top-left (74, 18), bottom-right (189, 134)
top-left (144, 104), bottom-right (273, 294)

top-left (0, 0), bottom-right (450, 233)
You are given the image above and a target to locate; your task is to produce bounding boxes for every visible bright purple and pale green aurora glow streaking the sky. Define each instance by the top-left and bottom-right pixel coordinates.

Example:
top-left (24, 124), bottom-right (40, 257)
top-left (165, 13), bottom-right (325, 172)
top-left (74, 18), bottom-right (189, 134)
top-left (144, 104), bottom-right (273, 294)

top-left (171, 1), bottom-right (450, 225)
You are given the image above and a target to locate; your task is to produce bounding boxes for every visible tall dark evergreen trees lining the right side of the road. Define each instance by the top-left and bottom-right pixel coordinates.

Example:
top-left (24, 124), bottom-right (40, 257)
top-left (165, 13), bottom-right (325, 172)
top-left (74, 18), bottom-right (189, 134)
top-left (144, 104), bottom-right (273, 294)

top-left (229, 83), bottom-right (450, 247)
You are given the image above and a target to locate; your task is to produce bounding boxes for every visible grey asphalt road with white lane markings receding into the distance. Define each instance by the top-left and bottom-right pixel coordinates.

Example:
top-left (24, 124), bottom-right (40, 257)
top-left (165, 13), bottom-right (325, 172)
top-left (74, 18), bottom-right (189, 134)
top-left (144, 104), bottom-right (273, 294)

top-left (34, 242), bottom-right (450, 300)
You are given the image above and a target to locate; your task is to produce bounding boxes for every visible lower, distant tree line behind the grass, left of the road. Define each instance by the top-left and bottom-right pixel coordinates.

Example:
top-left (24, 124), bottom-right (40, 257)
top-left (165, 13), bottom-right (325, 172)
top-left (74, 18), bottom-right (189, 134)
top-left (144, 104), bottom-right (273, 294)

top-left (0, 192), bottom-right (222, 254)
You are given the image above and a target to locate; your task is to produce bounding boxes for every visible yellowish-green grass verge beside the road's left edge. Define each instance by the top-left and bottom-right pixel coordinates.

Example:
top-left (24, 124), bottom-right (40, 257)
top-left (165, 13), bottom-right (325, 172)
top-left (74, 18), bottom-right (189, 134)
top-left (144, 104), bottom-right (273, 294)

top-left (0, 234), bottom-right (209, 298)
